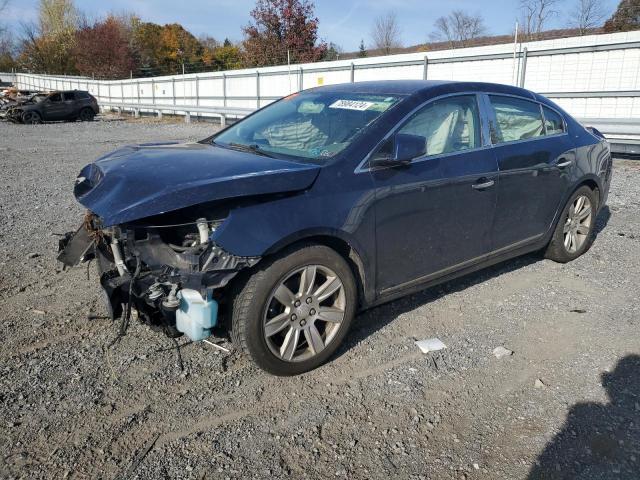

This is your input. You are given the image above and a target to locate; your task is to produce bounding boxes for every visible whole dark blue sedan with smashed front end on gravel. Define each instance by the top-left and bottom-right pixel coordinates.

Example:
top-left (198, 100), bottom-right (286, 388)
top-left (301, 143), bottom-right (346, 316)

top-left (59, 81), bottom-right (612, 375)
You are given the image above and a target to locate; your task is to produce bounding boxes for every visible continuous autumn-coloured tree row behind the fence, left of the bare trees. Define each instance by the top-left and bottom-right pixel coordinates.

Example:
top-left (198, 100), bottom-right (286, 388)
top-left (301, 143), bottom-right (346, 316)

top-left (0, 0), bottom-right (330, 79)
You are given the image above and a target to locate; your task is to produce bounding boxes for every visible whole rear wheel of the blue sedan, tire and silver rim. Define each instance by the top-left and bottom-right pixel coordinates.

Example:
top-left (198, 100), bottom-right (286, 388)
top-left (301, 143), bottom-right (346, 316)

top-left (545, 185), bottom-right (598, 263)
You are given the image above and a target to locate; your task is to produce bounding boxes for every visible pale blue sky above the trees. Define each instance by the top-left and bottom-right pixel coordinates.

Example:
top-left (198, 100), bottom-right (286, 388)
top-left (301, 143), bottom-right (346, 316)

top-left (3, 0), bottom-right (618, 51)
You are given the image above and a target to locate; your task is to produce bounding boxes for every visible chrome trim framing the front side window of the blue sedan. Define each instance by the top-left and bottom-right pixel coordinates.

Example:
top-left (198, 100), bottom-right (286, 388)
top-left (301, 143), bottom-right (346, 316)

top-left (353, 91), bottom-right (484, 174)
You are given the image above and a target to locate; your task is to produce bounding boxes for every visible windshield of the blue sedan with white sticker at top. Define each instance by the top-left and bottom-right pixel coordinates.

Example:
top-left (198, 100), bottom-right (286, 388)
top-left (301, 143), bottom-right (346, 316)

top-left (214, 92), bottom-right (400, 163)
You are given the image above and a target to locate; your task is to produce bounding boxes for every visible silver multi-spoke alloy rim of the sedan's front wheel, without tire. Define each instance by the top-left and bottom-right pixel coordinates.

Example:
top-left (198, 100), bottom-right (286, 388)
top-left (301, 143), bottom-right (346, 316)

top-left (263, 265), bottom-right (346, 362)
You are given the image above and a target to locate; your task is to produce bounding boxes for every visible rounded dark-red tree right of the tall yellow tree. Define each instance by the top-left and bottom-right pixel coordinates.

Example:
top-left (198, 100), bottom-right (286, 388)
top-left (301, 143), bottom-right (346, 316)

top-left (73, 17), bottom-right (135, 79)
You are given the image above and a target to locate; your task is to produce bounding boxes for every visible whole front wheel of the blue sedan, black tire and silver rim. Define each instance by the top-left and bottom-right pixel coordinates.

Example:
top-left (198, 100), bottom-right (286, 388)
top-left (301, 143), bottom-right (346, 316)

top-left (231, 245), bottom-right (357, 376)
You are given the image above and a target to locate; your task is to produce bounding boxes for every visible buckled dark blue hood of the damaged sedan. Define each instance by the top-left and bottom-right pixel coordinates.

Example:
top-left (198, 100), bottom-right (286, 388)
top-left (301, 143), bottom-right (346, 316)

top-left (74, 143), bottom-right (320, 226)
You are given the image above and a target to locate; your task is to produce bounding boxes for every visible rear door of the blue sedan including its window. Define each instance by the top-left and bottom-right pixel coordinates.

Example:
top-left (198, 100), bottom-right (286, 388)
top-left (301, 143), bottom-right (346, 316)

top-left (484, 95), bottom-right (575, 250)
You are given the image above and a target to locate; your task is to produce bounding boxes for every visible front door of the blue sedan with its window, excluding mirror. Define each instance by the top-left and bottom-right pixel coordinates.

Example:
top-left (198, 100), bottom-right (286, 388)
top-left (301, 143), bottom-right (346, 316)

top-left (371, 95), bottom-right (498, 294)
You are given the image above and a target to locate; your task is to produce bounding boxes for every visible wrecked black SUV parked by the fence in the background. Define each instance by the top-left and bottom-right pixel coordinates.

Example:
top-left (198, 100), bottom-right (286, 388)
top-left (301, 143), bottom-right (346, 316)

top-left (7, 90), bottom-right (99, 124)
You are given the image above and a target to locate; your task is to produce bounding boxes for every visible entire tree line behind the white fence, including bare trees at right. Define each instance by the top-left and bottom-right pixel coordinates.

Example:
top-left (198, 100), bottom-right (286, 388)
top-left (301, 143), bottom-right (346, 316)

top-left (0, 0), bottom-right (640, 79)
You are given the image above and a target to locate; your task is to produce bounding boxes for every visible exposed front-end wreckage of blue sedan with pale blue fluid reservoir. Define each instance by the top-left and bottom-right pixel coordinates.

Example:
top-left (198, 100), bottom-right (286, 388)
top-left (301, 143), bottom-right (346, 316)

top-left (58, 213), bottom-right (259, 340)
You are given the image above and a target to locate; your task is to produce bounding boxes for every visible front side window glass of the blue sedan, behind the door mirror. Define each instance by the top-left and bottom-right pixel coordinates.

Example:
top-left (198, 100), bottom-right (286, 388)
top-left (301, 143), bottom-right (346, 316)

top-left (398, 95), bottom-right (481, 155)
